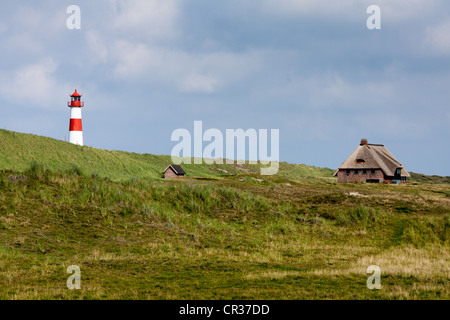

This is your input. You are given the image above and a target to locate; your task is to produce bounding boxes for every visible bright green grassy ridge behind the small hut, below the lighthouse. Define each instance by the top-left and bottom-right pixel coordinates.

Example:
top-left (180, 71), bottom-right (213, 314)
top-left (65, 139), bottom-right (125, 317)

top-left (0, 129), bottom-right (333, 180)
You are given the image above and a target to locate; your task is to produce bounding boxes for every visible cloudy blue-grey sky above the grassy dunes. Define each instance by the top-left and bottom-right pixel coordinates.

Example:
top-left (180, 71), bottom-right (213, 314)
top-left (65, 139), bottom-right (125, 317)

top-left (0, 0), bottom-right (450, 176)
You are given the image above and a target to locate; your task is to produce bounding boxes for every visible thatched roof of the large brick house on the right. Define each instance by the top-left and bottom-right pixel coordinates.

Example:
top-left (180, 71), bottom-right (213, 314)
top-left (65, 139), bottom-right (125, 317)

top-left (339, 140), bottom-right (410, 177)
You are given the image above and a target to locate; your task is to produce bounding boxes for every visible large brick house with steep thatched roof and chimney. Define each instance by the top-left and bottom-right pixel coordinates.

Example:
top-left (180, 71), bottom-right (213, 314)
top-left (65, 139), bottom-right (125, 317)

top-left (334, 139), bottom-right (410, 183)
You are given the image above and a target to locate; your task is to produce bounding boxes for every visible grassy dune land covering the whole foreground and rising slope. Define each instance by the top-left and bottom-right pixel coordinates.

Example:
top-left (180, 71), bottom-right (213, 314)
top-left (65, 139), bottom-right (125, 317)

top-left (0, 131), bottom-right (450, 299)
